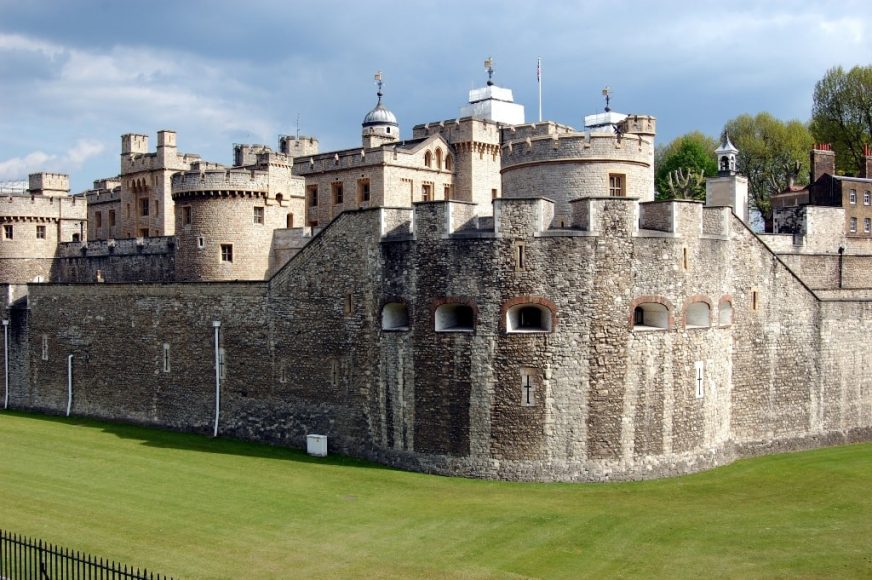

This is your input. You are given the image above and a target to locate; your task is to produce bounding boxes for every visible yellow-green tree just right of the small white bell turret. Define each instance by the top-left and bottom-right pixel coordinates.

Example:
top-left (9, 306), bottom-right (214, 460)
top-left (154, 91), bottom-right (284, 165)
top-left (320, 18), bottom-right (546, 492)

top-left (721, 113), bottom-right (814, 232)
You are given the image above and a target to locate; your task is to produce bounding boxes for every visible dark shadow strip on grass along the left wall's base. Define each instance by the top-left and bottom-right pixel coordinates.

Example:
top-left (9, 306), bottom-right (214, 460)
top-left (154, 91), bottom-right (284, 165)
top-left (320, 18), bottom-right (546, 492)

top-left (0, 410), bottom-right (400, 471)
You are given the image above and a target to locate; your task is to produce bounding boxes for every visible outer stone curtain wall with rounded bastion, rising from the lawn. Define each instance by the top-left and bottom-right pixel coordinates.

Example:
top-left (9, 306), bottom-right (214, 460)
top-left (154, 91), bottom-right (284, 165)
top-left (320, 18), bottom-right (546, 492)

top-left (10, 198), bottom-right (870, 481)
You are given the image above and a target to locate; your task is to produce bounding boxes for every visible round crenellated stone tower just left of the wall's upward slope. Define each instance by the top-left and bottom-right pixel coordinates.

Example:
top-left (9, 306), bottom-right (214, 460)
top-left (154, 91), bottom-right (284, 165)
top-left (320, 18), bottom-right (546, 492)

top-left (172, 169), bottom-right (287, 281)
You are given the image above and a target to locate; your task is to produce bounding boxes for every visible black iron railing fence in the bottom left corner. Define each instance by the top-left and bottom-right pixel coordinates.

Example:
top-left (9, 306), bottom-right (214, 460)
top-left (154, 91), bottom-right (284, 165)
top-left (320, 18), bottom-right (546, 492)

top-left (0, 530), bottom-right (171, 580)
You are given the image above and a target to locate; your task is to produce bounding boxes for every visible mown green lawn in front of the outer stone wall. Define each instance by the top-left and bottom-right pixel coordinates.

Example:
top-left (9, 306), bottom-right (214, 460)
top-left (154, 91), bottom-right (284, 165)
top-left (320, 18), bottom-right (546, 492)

top-left (0, 412), bottom-right (872, 578)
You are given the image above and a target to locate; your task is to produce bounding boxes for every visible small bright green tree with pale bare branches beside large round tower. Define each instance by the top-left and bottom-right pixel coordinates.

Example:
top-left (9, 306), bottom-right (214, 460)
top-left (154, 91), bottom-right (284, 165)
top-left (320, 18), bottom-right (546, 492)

top-left (654, 131), bottom-right (718, 199)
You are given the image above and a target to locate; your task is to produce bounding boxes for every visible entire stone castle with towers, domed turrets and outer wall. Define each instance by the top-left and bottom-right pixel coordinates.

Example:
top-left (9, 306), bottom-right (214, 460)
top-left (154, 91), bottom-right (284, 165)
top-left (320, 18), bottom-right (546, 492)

top-left (0, 70), bottom-right (872, 481)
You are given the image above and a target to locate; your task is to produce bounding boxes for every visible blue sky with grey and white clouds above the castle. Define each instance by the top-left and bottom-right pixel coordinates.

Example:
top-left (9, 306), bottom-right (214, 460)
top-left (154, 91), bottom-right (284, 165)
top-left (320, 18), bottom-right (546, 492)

top-left (0, 0), bottom-right (872, 192)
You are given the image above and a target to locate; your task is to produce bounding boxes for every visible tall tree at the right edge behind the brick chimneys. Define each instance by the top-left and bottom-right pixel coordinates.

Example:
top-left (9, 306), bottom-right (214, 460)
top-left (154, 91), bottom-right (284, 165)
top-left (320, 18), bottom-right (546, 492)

top-left (811, 66), bottom-right (872, 175)
